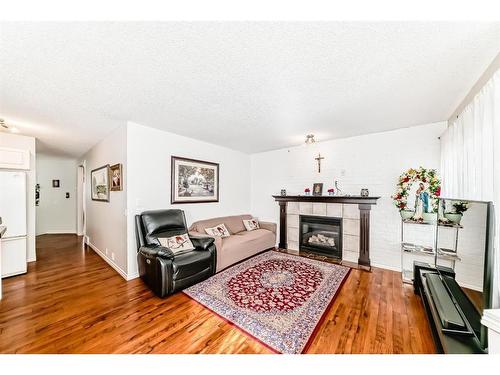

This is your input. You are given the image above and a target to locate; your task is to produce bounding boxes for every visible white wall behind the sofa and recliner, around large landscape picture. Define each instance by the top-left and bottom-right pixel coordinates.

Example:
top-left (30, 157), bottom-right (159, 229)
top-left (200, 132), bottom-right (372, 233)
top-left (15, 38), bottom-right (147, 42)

top-left (127, 122), bottom-right (250, 277)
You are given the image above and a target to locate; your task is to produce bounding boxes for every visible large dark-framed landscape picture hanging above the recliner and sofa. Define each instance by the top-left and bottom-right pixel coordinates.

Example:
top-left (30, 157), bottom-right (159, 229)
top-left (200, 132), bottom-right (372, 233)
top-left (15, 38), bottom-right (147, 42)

top-left (171, 156), bottom-right (219, 204)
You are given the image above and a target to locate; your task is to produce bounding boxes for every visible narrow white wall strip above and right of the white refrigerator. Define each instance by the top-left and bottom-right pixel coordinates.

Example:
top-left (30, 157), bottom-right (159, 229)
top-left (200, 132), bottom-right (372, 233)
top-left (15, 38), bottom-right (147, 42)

top-left (0, 133), bottom-right (36, 262)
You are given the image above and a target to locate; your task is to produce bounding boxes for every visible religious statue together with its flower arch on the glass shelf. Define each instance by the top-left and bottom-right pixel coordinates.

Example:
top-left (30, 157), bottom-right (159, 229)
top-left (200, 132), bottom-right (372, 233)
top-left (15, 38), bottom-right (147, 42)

top-left (392, 167), bottom-right (441, 222)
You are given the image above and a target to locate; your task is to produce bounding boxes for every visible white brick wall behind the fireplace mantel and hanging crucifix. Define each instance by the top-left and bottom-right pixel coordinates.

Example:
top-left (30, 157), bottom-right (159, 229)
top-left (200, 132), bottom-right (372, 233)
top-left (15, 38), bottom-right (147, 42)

top-left (251, 122), bottom-right (446, 270)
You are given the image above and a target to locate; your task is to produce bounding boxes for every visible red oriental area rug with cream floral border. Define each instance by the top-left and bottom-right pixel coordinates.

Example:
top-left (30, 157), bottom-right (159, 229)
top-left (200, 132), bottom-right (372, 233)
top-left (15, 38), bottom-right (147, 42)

top-left (184, 251), bottom-right (349, 354)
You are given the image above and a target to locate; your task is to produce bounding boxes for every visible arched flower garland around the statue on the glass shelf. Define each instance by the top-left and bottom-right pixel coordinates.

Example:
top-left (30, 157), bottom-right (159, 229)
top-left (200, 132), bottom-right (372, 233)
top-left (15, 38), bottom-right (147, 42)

top-left (392, 167), bottom-right (441, 212)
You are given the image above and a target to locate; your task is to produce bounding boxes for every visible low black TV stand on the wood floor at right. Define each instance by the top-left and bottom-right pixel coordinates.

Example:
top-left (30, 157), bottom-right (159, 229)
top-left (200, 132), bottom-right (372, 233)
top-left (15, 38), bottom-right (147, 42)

top-left (413, 262), bottom-right (485, 354)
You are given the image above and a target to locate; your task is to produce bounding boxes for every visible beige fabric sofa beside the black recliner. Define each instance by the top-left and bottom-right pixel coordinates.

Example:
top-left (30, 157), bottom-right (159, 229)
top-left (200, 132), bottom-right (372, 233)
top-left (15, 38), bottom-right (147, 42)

top-left (189, 215), bottom-right (276, 272)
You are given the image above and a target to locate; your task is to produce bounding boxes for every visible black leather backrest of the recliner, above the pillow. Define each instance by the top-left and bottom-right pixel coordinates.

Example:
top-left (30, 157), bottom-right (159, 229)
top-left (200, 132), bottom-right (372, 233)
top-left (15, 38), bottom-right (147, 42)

top-left (136, 209), bottom-right (187, 247)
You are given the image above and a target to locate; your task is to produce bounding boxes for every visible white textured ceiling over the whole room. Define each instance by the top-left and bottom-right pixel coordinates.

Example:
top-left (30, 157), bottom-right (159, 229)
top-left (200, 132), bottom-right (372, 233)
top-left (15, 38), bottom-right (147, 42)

top-left (0, 22), bottom-right (500, 156)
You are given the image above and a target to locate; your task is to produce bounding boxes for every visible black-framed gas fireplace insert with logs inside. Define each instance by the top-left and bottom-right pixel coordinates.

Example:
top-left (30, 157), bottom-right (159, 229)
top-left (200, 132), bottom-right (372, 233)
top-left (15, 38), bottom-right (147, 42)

top-left (299, 215), bottom-right (342, 259)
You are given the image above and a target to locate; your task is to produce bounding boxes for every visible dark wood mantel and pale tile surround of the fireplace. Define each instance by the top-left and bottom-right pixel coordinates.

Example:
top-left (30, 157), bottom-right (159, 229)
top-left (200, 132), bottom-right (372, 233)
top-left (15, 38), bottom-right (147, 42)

top-left (273, 195), bottom-right (380, 268)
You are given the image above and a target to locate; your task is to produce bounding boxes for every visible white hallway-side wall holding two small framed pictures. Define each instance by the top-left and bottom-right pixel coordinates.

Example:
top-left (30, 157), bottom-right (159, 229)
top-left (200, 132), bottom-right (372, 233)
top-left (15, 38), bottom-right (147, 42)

top-left (82, 126), bottom-right (127, 277)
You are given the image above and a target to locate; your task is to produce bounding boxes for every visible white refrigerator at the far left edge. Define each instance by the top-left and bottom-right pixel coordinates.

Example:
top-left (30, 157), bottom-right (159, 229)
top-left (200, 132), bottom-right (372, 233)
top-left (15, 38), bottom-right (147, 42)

top-left (0, 171), bottom-right (27, 278)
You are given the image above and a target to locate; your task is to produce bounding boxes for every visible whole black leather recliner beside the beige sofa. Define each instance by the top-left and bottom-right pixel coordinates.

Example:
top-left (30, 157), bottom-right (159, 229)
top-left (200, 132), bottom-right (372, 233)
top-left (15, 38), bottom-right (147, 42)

top-left (135, 210), bottom-right (217, 297)
